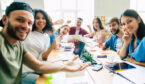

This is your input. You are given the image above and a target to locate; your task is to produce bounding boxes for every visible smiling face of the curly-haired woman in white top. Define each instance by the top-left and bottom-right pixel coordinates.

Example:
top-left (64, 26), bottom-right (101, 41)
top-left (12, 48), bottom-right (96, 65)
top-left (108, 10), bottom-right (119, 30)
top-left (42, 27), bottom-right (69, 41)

top-left (35, 12), bottom-right (46, 32)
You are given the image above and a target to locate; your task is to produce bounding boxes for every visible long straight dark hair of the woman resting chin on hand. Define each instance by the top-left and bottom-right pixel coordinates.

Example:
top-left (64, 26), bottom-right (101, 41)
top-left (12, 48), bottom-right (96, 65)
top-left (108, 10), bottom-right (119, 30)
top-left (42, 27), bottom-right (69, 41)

top-left (120, 9), bottom-right (145, 40)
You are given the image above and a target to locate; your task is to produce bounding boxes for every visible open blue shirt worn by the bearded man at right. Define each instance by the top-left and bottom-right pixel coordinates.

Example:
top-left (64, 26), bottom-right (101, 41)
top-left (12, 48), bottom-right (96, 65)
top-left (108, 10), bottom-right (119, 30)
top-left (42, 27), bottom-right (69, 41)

top-left (105, 35), bottom-right (118, 51)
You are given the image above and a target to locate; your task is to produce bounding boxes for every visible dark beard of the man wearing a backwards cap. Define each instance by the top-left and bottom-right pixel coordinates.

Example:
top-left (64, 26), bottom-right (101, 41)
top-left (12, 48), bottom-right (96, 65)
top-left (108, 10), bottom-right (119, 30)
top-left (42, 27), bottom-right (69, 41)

top-left (7, 21), bottom-right (24, 41)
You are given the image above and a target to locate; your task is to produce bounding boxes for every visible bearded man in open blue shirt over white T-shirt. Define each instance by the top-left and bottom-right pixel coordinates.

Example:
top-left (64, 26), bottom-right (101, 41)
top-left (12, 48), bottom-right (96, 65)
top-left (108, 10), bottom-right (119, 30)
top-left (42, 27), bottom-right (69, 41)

top-left (103, 17), bottom-right (124, 52)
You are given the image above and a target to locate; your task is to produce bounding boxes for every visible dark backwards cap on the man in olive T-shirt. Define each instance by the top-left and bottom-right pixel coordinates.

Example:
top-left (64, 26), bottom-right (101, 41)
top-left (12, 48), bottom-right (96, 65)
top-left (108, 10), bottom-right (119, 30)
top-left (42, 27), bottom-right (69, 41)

top-left (5, 2), bottom-right (34, 16)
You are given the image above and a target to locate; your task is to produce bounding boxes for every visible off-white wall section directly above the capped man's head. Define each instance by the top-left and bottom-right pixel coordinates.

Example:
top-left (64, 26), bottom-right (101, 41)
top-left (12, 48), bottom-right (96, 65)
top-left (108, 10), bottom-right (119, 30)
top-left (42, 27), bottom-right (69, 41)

top-left (14, 0), bottom-right (44, 9)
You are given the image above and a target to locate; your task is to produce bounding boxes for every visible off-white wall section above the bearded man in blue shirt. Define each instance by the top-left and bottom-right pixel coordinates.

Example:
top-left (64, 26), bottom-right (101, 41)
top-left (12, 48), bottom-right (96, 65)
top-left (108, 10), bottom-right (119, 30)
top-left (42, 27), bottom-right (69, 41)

top-left (94, 0), bottom-right (130, 17)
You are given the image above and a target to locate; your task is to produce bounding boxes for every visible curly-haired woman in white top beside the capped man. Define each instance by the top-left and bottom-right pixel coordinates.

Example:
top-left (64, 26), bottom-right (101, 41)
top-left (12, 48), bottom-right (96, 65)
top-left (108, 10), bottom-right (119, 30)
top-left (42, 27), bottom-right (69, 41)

top-left (22, 10), bottom-right (55, 84)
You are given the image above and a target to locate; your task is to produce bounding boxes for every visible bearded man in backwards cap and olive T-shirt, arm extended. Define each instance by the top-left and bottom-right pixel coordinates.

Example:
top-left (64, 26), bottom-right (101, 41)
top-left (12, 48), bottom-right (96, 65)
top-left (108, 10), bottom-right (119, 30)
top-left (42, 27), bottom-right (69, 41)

top-left (0, 2), bottom-right (90, 84)
